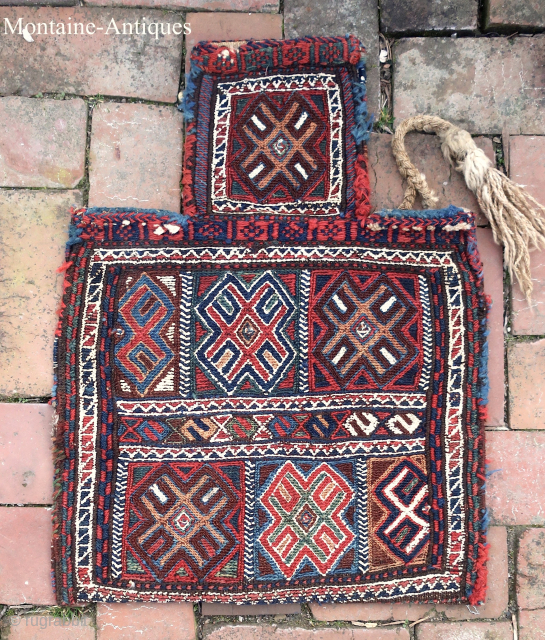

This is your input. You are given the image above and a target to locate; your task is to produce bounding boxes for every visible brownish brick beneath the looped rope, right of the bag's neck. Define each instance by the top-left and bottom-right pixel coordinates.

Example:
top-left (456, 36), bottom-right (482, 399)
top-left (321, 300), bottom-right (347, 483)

top-left (369, 133), bottom-right (494, 224)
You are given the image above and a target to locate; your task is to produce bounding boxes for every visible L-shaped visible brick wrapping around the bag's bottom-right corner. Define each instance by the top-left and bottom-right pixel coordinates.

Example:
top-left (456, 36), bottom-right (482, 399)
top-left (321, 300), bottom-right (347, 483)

top-left (436, 524), bottom-right (509, 620)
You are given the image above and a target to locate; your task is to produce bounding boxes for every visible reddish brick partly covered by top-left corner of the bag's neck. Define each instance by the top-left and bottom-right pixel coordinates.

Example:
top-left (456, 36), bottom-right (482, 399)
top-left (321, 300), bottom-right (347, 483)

top-left (185, 12), bottom-right (282, 72)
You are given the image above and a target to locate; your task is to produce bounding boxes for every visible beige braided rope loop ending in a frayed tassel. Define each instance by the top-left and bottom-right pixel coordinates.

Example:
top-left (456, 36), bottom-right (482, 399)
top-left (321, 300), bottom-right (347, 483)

top-left (392, 115), bottom-right (545, 302)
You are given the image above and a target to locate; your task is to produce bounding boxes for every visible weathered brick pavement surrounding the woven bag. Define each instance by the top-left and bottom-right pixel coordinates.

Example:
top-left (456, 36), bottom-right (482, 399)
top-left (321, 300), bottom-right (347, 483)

top-left (0, 0), bottom-right (545, 640)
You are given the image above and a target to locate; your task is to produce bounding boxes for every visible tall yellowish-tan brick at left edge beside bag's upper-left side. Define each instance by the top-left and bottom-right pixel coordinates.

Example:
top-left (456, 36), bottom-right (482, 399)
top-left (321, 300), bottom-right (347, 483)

top-left (0, 189), bottom-right (81, 396)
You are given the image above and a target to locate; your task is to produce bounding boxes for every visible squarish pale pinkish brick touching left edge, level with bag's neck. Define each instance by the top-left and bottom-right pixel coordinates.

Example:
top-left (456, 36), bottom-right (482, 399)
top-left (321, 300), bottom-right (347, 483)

top-left (0, 97), bottom-right (87, 188)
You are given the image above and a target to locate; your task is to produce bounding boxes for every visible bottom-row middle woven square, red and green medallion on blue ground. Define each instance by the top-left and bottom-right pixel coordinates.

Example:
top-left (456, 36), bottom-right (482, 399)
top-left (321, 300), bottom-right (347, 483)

top-left (255, 460), bottom-right (357, 579)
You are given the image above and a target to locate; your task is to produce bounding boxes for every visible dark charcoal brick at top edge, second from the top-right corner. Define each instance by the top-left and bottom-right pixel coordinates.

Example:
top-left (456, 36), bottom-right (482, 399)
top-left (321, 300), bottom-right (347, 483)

top-left (380, 0), bottom-right (478, 34)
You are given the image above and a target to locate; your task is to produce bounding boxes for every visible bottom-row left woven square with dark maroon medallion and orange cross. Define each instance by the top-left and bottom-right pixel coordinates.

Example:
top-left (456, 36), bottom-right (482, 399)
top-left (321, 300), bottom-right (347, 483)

top-left (123, 462), bottom-right (244, 582)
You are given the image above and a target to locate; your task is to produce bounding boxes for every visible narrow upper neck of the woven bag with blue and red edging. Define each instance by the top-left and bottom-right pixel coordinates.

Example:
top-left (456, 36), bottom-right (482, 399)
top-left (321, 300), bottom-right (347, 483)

top-left (183, 37), bottom-right (369, 217)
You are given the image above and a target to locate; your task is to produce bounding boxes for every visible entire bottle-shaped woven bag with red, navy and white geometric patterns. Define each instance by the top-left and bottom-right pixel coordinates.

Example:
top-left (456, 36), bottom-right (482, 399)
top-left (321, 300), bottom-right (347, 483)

top-left (54, 38), bottom-right (487, 603)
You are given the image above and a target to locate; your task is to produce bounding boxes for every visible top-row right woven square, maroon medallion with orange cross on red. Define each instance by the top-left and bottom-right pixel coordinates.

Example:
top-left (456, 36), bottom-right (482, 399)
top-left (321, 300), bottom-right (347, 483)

top-left (309, 271), bottom-right (422, 391)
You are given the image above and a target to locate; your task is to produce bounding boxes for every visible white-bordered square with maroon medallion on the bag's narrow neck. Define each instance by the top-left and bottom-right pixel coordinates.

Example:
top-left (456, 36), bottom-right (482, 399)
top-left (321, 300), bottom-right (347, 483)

top-left (209, 72), bottom-right (348, 215)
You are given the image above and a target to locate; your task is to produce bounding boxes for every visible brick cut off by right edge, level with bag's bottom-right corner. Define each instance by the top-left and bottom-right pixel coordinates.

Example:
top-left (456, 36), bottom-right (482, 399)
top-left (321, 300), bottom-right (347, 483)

top-left (517, 529), bottom-right (545, 609)
